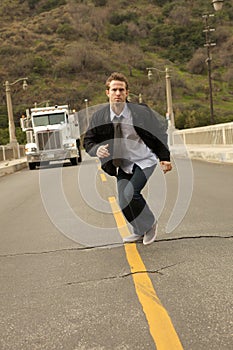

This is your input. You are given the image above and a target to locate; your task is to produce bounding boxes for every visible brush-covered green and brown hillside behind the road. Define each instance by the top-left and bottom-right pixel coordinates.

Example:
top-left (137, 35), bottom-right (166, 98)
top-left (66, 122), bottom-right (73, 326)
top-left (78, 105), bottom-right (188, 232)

top-left (0, 0), bottom-right (233, 143)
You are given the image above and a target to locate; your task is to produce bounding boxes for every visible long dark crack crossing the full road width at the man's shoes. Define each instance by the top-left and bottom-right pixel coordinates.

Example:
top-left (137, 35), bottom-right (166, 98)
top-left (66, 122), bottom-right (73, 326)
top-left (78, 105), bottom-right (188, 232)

top-left (0, 235), bottom-right (233, 258)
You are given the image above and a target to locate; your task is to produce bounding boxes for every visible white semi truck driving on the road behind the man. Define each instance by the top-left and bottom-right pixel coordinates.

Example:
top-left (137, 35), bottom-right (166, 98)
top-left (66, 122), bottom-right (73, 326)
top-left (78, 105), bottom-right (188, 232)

top-left (20, 105), bottom-right (82, 170)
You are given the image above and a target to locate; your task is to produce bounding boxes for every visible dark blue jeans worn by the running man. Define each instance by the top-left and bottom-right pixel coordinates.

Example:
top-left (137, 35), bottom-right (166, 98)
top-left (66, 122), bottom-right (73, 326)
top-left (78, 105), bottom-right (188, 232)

top-left (117, 164), bottom-right (156, 236)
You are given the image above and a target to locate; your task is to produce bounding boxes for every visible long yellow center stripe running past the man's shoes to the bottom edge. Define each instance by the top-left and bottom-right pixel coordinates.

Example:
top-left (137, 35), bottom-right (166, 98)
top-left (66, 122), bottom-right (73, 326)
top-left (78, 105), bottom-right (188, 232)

top-left (108, 197), bottom-right (183, 350)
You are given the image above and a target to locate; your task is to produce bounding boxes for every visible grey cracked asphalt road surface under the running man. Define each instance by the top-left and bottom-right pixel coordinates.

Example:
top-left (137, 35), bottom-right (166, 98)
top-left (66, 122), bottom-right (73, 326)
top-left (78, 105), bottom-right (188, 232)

top-left (0, 157), bottom-right (233, 350)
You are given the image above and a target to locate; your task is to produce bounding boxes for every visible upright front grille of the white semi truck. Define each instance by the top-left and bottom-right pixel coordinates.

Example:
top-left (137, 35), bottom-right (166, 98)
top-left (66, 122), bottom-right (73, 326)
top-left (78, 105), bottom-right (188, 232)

top-left (37, 131), bottom-right (61, 151)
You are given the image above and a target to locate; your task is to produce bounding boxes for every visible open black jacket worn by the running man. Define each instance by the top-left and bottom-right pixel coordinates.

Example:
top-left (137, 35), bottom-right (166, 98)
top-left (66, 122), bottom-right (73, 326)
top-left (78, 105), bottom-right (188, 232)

top-left (84, 103), bottom-right (170, 176)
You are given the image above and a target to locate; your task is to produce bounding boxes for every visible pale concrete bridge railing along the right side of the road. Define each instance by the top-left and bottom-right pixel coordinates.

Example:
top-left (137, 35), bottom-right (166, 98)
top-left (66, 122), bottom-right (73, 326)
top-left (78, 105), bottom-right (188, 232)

top-left (172, 122), bottom-right (233, 147)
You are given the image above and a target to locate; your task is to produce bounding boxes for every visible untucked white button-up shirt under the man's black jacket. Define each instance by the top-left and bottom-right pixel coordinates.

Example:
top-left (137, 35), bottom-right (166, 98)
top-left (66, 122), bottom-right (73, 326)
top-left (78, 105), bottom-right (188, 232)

top-left (110, 104), bottom-right (158, 174)
